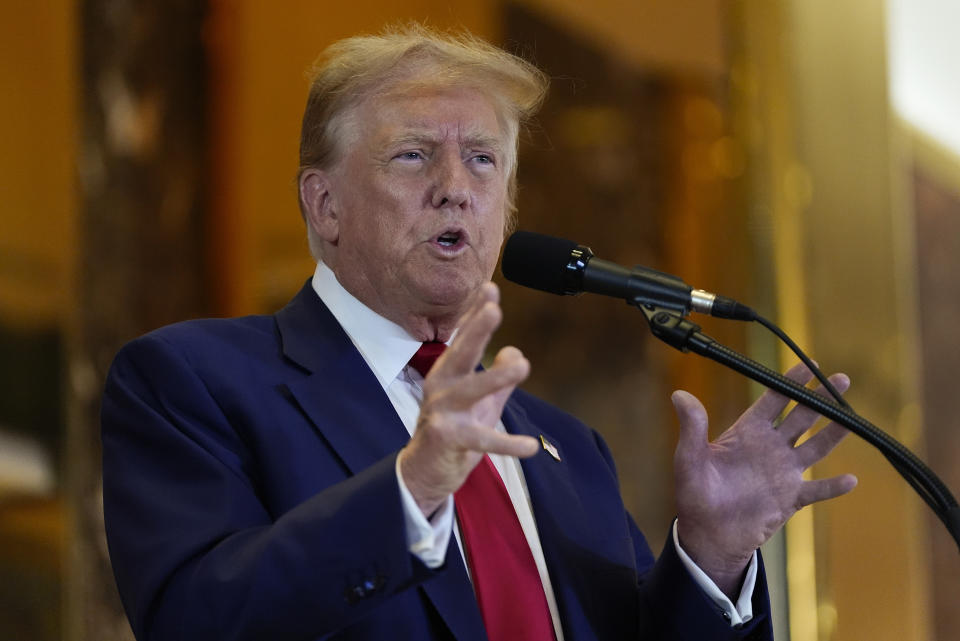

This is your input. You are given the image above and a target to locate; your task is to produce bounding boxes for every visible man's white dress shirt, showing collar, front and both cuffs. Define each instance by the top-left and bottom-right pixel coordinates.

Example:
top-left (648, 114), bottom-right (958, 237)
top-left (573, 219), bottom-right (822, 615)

top-left (312, 261), bottom-right (757, 641)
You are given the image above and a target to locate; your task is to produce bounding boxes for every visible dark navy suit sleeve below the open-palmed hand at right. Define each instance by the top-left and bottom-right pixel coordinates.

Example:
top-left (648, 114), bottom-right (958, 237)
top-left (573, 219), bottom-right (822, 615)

top-left (597, 435), bottom-right (773, 641)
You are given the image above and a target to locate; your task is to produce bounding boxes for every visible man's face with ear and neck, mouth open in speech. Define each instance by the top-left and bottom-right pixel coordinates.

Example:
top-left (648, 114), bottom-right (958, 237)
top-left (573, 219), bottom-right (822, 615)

top-left (318, 88), bottom-right (510, 329)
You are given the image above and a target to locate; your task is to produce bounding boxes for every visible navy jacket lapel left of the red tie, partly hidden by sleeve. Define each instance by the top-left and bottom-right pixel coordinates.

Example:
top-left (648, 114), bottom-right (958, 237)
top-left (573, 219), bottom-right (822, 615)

top-left (276, 281), bottom-right (487, 641)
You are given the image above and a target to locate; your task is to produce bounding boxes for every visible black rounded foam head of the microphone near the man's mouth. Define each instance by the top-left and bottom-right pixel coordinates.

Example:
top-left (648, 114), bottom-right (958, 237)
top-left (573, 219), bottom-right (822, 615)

top-left (501, 231), bottom-right (577, 295)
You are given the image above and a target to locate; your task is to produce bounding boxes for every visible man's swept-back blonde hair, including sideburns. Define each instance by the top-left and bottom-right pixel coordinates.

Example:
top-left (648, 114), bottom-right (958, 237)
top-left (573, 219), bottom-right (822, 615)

top-left (297, 23), bottom-right (549, 256)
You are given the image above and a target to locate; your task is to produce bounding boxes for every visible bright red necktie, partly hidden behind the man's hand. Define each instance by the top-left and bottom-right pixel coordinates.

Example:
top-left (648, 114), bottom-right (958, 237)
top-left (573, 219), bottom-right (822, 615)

top-left (410, 343), bottom-right (556, 641)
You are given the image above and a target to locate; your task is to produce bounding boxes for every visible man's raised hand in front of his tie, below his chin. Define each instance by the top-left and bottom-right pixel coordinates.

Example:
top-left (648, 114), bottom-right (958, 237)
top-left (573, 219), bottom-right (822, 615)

top-left (400, 283), bottom-right (539, 517)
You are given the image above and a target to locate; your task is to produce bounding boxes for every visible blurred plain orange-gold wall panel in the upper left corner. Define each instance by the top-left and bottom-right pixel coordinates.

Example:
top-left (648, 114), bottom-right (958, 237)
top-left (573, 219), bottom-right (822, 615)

top-left (0, 0), bottom-right (77, 326)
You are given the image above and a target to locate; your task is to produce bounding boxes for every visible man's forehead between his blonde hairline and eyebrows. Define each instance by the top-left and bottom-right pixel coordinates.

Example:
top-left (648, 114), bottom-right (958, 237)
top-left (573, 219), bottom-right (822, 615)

top-left (355, 87), bottom-right (506, 147)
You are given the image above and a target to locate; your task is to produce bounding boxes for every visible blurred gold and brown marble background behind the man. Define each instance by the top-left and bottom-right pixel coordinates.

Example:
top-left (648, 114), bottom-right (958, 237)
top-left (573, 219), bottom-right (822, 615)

top-left (0, 0), bottom-right (960, 641)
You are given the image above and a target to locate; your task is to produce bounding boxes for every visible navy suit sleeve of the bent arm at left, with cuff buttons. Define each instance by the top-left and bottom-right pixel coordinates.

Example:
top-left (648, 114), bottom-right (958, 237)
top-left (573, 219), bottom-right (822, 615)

top-left (102, 335), bottom-right (431, 641)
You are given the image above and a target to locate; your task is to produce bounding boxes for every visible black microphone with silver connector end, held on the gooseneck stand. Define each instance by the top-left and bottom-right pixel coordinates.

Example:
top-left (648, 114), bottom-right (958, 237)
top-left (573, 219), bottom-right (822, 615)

top-left (502, 231), bottom-right (757, 320)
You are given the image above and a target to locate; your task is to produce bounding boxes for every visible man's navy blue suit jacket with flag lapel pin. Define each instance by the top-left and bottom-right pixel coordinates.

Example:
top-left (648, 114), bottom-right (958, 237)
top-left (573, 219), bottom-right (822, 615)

top-left (102, 283), bottom-right (771, 641)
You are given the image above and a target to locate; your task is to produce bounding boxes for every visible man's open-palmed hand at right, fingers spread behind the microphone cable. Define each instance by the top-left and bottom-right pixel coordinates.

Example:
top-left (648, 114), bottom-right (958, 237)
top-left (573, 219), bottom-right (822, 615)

top-left (672, 365), bottom-right (857, 595)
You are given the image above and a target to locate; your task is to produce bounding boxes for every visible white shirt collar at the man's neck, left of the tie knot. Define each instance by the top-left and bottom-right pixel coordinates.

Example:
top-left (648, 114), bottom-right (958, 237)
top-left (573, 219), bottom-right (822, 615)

top-left (311, 261), bottom-right (420, 389)
